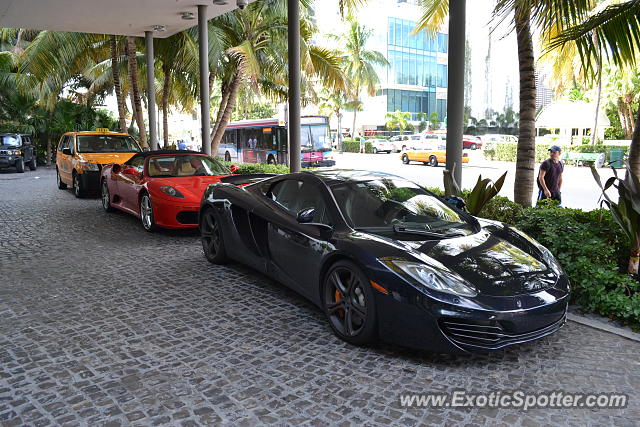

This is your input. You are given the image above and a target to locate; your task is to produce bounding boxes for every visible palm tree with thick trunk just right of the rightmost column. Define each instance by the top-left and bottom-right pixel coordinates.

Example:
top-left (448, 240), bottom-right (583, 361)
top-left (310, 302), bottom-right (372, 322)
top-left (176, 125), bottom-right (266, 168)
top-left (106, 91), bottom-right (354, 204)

top-left (414, 0), bottom-right (592, 206)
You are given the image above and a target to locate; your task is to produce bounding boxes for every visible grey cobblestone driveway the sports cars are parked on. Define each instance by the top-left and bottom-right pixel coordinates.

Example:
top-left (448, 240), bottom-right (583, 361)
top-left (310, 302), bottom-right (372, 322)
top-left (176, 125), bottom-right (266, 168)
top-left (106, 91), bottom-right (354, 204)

top-left (0, 168), bottom-right (640, 426)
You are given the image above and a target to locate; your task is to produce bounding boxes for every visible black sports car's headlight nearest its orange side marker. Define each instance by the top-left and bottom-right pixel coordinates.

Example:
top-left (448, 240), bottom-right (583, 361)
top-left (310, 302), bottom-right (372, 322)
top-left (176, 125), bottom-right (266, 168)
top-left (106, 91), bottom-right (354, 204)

top-left (390, 260), bottom-right (478, 297)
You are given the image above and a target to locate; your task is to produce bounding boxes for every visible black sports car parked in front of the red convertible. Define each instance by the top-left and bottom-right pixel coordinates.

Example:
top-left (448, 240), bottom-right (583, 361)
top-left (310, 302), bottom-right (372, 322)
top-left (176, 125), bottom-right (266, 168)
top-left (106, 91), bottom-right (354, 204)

top-left (200, 170), bottom-right (569, 353)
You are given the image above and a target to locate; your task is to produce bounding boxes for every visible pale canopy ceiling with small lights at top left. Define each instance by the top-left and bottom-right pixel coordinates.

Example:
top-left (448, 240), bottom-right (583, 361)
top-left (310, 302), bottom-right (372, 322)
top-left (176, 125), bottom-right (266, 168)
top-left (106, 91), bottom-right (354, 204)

top-left (0, 0), bottom-right (252, 38)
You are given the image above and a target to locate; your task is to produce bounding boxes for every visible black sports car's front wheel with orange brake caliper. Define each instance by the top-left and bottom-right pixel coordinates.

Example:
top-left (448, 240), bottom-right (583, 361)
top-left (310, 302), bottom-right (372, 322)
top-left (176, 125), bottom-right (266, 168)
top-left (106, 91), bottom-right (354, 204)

top-left (322, 261), bottom-right (377, 345)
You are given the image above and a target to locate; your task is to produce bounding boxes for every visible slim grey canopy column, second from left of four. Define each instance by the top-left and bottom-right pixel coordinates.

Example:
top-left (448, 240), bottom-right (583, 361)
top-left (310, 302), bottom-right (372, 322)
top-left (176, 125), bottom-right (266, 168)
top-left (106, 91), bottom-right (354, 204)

top-left (198, 4), bottom-right (212, 155)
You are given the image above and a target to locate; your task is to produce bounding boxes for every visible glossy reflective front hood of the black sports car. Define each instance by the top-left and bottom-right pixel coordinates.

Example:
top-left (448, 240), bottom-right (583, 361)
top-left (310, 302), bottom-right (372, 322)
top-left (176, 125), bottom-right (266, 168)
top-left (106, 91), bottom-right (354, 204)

top-left (388, 228), bottom-right (558, 296)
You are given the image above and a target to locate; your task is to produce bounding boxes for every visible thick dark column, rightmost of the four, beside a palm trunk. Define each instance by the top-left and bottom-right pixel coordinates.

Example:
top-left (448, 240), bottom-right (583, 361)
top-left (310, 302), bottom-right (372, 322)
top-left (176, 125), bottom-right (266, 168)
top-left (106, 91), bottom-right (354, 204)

top-left (447, 0), bottom-right (466, 186)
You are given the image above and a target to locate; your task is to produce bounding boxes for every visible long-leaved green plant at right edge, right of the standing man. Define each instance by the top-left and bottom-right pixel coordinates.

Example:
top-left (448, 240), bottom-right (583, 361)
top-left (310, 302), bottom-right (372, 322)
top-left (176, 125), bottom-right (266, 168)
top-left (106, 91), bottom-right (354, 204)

top-left (591, 161), bottom-right (640, 274)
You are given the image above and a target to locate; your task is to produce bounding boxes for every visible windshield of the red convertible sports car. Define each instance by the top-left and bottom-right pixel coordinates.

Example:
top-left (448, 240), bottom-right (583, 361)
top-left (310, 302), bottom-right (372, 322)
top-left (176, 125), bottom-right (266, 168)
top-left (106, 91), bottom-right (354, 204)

top-left (147, 154), bottom-right (231, 178)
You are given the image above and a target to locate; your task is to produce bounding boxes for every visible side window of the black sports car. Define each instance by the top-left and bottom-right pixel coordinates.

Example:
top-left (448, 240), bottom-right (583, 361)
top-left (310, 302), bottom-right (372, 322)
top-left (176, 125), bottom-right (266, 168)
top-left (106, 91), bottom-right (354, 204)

top-left (267, 179), bottom-right (331, 225)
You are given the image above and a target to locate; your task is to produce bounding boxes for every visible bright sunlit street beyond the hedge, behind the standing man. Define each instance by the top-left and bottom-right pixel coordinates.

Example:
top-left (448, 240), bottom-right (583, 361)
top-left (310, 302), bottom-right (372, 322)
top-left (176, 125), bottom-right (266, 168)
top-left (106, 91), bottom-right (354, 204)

top-left (335, 150), bottom-right (617, 210)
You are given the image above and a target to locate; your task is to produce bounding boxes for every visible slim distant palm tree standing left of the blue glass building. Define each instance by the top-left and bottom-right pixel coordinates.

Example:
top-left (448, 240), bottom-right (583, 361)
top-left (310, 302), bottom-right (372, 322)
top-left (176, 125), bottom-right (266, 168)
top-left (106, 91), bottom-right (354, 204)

top-left (333, 16), bottom-right (389, 137)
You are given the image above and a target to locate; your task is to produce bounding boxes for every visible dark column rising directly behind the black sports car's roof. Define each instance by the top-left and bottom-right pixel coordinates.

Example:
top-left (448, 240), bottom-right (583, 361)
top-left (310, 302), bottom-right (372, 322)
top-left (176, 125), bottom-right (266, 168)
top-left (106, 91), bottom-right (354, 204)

top-left (287, 0), bottom-right (300, 172)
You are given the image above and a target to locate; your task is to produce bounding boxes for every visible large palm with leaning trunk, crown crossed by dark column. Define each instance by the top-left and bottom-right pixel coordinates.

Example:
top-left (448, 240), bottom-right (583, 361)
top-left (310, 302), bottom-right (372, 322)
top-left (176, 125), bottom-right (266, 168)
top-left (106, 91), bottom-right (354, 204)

top-left (210, 0), bottom-right (346, 153)
